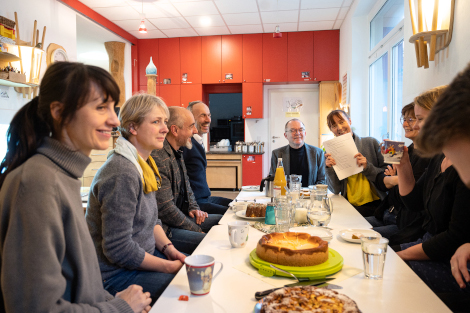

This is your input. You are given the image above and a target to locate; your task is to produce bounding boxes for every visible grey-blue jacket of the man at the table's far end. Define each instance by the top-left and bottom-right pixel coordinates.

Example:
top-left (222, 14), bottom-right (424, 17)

top-left (269, 144), bottom-right (326, 185)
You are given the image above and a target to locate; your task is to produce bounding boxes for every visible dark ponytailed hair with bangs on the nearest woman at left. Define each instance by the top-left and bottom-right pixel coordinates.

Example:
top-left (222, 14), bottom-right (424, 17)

top-left (0, 62), bottom-right (120, 188)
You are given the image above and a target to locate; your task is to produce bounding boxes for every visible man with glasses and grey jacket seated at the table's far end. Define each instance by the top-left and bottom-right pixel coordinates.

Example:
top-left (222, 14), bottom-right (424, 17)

top-left (269, 118), bottom-right (326, 187)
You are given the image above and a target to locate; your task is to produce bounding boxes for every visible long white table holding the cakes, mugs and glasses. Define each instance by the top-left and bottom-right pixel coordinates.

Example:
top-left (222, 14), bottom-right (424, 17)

top-left (150, 192), bottom-right (450, 313)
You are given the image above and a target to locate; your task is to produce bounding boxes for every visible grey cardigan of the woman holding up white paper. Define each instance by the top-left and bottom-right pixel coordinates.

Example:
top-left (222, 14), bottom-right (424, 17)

top-left (326, 134), bottom-right (387, 200)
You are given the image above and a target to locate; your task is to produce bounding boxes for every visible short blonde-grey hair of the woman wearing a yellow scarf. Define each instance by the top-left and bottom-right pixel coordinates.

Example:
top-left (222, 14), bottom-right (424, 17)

top-left (118, 93), bottom-right (170, 139)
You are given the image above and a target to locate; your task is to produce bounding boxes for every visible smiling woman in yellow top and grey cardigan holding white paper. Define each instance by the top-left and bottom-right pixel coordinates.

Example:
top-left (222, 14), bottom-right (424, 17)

top-left (325, 110), bottom-right (386, 217)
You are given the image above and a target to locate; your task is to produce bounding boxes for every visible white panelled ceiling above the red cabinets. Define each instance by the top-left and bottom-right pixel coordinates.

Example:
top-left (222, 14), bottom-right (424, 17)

top-left (80, 0), bottom-right (354, 39)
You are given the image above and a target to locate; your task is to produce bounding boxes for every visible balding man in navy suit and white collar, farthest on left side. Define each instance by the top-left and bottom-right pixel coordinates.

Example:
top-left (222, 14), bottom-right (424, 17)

top-left (183, 101), bottom-right (232, 214)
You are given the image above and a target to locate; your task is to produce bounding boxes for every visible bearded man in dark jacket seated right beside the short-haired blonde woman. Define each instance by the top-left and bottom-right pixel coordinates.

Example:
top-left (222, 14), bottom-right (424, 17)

top-left (152, 107), bottom-right (222, 254)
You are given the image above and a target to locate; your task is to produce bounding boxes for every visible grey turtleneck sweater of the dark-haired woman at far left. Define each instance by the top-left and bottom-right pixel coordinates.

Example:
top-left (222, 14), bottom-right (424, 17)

top-left (0, 138), bottom-right (132, 313)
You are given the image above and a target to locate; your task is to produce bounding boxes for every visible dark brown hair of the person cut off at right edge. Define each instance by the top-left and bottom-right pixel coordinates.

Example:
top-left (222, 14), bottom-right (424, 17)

top-left (416, 64), bottom-right (470, 157)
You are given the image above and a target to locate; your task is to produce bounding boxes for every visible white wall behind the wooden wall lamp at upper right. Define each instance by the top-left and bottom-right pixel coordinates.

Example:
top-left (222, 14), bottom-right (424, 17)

top-left (403, 0), bottom-right (470, 103)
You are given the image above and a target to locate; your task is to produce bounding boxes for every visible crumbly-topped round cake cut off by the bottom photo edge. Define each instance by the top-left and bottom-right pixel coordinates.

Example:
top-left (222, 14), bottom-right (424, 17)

top-left (260, 286), bottom-right (361, 313)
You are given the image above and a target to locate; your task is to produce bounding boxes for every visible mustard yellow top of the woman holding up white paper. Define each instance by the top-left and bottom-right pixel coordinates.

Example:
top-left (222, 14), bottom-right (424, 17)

top-left (346, 173), bottom-right (380, 206)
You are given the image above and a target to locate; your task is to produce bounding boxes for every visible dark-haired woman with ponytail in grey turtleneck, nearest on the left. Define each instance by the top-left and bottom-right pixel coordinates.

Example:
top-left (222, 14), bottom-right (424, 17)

top-left (0, 62), bottom-right (151, 312)
